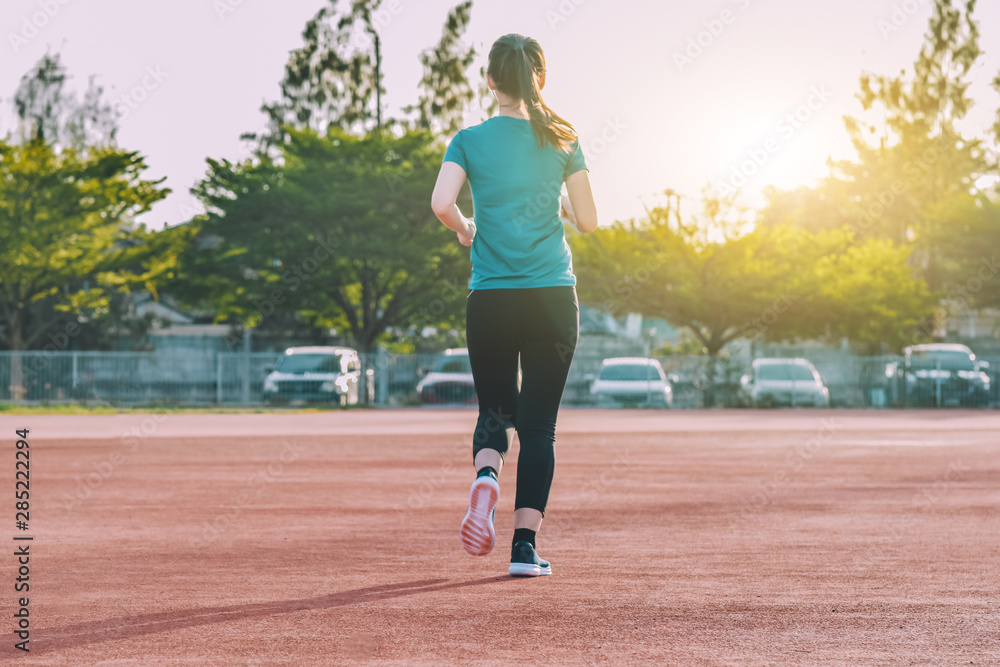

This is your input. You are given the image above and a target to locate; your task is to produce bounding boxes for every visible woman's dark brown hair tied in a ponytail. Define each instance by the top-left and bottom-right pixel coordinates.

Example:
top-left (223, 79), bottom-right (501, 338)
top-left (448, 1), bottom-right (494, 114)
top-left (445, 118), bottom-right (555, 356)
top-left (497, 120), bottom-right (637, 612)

top-left (486, 33), bottom-right (577, 152)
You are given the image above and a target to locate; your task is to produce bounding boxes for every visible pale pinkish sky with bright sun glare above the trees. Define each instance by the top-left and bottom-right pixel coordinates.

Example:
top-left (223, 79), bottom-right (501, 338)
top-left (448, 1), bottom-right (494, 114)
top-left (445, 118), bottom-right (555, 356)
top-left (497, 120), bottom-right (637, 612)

top-left (0, 0), bottom-right (1000, 229)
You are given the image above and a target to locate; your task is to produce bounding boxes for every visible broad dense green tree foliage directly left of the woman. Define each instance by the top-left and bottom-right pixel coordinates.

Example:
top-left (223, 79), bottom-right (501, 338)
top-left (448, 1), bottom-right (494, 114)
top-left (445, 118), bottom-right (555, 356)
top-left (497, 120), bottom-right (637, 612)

top-left (179, 128), bottom-right (468, 352)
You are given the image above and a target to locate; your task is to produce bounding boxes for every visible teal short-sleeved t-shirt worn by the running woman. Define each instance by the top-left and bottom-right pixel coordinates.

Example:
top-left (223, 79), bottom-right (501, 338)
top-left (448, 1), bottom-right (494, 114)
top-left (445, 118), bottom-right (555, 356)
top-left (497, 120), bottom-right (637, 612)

top-left (444, 116), bottom-right (587, 289)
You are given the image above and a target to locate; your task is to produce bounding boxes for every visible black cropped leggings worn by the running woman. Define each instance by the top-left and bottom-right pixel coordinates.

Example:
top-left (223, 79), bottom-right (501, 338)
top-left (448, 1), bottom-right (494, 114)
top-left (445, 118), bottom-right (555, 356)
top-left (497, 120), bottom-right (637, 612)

top-left (466, 287), bottom-right (580, 515)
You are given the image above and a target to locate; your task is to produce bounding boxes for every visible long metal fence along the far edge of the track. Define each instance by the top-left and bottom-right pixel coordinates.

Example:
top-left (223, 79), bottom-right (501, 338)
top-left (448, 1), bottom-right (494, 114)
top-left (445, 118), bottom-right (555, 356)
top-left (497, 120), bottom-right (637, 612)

top-left (0, 348), bottom-right (1000, 409)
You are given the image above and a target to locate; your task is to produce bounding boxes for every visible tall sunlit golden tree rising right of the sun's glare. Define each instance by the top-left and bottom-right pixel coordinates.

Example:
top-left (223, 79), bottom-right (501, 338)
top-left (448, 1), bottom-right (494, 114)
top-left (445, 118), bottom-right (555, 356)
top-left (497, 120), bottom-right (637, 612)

top-left (829, 0), bottom-right (990, 289)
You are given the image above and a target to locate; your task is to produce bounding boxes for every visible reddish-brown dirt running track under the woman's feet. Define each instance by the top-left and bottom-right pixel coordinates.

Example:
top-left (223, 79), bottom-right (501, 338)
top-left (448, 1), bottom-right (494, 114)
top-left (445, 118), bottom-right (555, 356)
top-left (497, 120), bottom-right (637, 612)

top-left (0, 410), bottom-right (1000, 667)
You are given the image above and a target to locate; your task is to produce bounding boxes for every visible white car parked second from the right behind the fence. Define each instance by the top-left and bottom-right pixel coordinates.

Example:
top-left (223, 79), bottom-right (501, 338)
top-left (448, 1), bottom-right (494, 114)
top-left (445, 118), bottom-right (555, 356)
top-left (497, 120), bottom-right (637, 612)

top-left (740, 359), bottom-right (830, 408)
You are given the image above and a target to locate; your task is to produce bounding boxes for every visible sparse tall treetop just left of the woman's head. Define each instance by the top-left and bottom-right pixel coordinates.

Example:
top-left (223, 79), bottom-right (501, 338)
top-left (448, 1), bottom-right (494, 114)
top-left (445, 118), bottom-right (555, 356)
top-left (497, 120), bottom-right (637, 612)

top-left (404, 0), bottom-right (485, 135)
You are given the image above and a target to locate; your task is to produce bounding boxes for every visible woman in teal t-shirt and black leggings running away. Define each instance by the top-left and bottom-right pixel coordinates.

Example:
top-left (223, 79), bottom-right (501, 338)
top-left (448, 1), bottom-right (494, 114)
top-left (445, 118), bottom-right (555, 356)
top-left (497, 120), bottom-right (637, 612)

top-left (431, 34), bottom-right (597, 576)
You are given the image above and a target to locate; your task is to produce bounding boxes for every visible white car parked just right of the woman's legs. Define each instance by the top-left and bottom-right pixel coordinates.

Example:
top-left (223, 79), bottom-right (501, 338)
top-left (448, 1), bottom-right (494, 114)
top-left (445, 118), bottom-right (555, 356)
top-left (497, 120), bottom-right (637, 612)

top-left (590, 357), bottom-right (674, 408)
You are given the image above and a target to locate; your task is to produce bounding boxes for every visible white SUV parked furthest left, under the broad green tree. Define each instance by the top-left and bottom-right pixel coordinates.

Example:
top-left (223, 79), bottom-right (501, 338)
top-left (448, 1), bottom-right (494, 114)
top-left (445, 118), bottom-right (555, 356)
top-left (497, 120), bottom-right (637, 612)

top-left (263, 346), bottom-right (371, 405)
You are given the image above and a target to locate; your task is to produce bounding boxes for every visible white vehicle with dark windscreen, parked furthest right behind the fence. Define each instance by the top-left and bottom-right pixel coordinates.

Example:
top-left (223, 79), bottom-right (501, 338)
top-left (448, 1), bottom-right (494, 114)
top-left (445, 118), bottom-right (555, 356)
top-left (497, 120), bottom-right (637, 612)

top-left (885, 343), bottom-right (990, 407)
